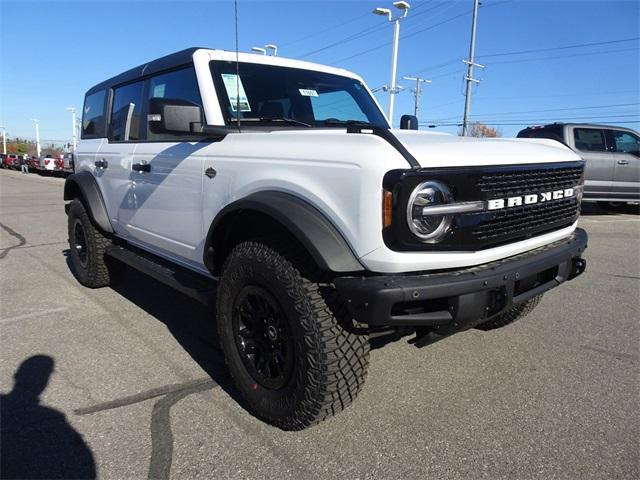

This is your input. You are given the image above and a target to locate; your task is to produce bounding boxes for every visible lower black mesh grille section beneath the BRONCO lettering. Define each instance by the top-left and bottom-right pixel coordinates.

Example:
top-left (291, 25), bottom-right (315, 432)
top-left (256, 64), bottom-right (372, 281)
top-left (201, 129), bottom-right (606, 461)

top-left (473, 197), bottom-right (579, 241)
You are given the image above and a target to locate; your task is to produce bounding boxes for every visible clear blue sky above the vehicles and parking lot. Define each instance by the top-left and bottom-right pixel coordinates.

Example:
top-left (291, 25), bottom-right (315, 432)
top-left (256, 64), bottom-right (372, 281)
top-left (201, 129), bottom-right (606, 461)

top-left (0, 0), bottom-right (640, 143)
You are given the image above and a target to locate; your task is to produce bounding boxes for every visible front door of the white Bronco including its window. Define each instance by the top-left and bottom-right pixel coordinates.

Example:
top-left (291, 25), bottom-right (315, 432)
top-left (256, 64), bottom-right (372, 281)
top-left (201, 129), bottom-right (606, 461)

top-left (119, 66), bottom-right (209, 265)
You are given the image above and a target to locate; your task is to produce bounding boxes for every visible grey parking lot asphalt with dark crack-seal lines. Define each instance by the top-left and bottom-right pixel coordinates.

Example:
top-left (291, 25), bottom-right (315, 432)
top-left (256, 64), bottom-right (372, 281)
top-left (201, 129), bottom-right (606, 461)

top-left (0, 167), bottom-right (640, 479)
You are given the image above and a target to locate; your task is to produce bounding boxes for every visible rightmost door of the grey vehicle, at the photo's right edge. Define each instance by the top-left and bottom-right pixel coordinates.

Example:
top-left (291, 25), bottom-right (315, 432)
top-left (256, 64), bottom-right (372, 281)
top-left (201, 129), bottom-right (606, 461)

top-left (607, 129), bottom-right (640, 200)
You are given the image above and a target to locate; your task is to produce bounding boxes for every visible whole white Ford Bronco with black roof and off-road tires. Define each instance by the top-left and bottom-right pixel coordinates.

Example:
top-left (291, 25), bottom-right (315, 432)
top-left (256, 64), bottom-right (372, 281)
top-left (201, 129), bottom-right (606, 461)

top-left (64, 48), bottom-right (587, 430)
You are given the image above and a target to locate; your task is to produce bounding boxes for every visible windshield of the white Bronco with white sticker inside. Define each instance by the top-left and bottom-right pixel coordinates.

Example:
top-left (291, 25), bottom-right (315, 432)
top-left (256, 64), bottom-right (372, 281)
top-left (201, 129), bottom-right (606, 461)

top-left (211, 61), bottom-right (388, 128)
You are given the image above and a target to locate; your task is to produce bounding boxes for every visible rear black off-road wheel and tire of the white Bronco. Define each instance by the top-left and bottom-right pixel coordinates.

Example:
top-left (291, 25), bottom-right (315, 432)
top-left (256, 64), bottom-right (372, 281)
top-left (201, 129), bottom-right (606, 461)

top-left (67, 198), bottom-right (124, 288)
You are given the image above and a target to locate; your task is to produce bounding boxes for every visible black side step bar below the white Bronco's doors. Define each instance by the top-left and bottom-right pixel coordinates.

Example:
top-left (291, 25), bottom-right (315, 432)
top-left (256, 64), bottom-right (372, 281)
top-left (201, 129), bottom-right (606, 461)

top-left (106, 245), bottom-right (217, 305)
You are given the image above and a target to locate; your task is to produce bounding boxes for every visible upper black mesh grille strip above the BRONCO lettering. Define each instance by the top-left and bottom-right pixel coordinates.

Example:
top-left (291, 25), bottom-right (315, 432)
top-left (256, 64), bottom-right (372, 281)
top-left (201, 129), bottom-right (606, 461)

top-left (476, 167), bottom-right (583, 198)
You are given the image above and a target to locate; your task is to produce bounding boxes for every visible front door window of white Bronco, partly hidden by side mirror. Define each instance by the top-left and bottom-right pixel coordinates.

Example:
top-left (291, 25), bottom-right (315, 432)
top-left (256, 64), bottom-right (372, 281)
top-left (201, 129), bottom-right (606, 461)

top-left (147, 67), bottom-right (202, 140)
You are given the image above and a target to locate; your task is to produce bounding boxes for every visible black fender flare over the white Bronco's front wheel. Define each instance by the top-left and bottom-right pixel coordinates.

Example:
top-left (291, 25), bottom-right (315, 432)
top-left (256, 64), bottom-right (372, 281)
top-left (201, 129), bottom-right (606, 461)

top-left (204, 191), bottom-right (364, 272)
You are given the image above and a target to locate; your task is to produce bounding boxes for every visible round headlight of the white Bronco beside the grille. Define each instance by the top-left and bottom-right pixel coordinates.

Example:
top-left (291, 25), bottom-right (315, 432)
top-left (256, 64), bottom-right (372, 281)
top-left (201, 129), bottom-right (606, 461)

top-left (407, 180), bottom-right (453, 243)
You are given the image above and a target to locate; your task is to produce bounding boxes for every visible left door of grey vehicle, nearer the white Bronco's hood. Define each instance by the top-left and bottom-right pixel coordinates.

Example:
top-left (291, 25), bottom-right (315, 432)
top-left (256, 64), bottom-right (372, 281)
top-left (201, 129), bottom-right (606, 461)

top-left (570, 127), bottom-right (614, 198)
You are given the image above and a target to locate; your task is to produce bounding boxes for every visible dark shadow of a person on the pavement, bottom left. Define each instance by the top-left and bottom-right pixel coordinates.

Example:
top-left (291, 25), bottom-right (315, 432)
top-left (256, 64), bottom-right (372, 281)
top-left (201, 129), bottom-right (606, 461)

top-left (0, 355), bottom-right (96, 479)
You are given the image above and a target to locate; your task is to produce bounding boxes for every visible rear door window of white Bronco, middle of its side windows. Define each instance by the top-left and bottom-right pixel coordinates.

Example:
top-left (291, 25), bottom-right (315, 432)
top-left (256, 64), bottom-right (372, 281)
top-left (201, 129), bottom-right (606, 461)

top-left (110, 82), bottom-right (144, 142)
